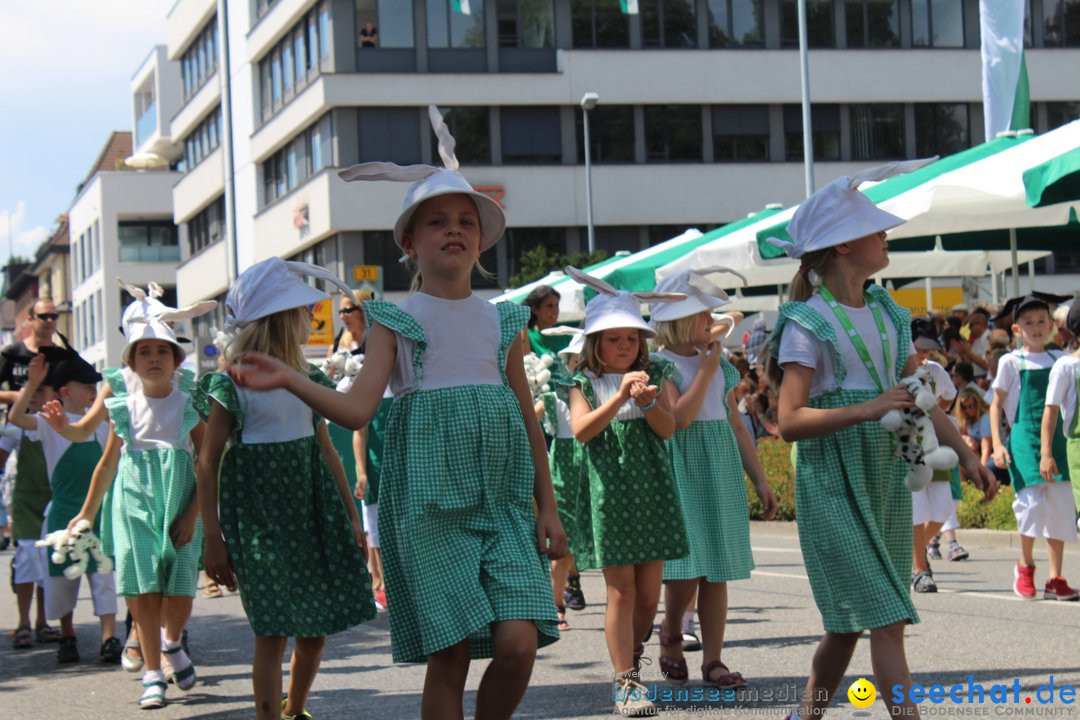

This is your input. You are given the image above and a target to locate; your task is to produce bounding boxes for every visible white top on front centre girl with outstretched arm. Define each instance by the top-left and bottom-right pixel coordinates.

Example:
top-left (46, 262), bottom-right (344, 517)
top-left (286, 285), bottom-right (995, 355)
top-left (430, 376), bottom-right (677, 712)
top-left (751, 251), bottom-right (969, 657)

top-left (390, 293), bottom-right (502, 395)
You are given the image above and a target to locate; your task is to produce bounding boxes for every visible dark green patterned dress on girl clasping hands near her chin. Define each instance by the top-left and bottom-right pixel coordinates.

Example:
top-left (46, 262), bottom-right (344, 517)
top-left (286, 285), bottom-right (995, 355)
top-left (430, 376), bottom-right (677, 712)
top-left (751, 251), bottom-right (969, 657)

top-left (575, 359), bottom-right (689, 570)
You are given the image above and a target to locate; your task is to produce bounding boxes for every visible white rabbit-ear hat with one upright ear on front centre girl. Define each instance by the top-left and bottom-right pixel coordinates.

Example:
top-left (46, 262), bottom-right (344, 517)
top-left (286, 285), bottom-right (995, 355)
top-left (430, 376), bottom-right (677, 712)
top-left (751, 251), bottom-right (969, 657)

top-left (338, 105), bottom-right (507, 252)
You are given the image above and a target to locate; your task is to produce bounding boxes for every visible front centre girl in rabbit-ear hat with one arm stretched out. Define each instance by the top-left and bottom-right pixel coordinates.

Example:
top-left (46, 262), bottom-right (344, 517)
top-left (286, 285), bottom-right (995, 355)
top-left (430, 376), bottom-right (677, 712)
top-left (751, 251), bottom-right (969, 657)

top-left (231, 107), bottom-right (566, 719)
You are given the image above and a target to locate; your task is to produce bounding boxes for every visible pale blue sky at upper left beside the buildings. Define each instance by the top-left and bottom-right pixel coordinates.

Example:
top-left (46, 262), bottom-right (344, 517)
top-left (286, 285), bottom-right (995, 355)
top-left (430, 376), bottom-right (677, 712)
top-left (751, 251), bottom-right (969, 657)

top-left (0, 0), bottom-right (175, 263)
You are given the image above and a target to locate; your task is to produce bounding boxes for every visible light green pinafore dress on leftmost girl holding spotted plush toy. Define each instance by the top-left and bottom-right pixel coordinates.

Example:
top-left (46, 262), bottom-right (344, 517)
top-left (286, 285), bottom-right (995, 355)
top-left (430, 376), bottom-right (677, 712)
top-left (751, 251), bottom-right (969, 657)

top-left (102, 368), bottom-right (202, 597)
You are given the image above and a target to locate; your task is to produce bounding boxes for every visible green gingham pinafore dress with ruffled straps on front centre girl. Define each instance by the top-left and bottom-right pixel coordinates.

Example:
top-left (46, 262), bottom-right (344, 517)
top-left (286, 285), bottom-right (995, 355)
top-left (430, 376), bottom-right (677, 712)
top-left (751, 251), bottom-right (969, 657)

top-left (364, 296), bottom-right (558, 663)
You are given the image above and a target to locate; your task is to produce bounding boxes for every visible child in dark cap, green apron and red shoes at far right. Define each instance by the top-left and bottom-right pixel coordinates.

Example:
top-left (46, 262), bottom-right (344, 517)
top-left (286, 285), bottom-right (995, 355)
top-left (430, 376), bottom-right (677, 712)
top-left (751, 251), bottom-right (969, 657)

top-left (990, 295), bottom-right (1080, 600)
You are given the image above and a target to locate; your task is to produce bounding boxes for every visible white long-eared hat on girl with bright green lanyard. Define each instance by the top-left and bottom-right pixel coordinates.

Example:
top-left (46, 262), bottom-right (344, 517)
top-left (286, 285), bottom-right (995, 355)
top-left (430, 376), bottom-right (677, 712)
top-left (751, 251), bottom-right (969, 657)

top-left (769, 155), bottom-right (937, 258)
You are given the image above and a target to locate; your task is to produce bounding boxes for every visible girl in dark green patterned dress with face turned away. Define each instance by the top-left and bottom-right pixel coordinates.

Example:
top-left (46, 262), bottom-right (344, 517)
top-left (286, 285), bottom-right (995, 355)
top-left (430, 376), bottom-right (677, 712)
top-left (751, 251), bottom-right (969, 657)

top-left (198, 257), bottom-right (375, 720)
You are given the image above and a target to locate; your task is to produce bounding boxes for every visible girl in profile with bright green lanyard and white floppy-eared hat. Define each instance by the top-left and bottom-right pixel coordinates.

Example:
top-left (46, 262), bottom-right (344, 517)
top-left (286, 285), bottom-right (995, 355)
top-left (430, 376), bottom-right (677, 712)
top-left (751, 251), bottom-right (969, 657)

top-left (768, 161), bottom-right (997, 718)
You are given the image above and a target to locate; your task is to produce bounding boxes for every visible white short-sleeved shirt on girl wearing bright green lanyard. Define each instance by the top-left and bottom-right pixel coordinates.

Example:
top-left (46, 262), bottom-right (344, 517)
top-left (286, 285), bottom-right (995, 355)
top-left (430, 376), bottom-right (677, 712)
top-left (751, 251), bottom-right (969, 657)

top-left (780, 294), bottom-right (915, 397)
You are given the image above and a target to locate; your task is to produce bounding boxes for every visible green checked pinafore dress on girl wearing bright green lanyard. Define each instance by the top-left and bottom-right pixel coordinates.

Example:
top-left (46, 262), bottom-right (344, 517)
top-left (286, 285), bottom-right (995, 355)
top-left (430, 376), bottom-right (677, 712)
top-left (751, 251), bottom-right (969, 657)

top-left (770, 285), bottom-right (919, 633)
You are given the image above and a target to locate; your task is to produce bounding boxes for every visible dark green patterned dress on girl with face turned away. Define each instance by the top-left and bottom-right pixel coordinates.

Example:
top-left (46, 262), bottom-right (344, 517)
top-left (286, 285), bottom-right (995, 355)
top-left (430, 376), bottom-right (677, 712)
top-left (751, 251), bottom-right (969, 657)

top-left (201, 368), bottom-right (375, 637)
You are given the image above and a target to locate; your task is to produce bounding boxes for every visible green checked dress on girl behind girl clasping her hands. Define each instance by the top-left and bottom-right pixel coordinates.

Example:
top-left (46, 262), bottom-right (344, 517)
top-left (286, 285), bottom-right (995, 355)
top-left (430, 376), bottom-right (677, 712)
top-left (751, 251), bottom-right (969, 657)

top-left (660, 352), bottom-right (754, 583)
